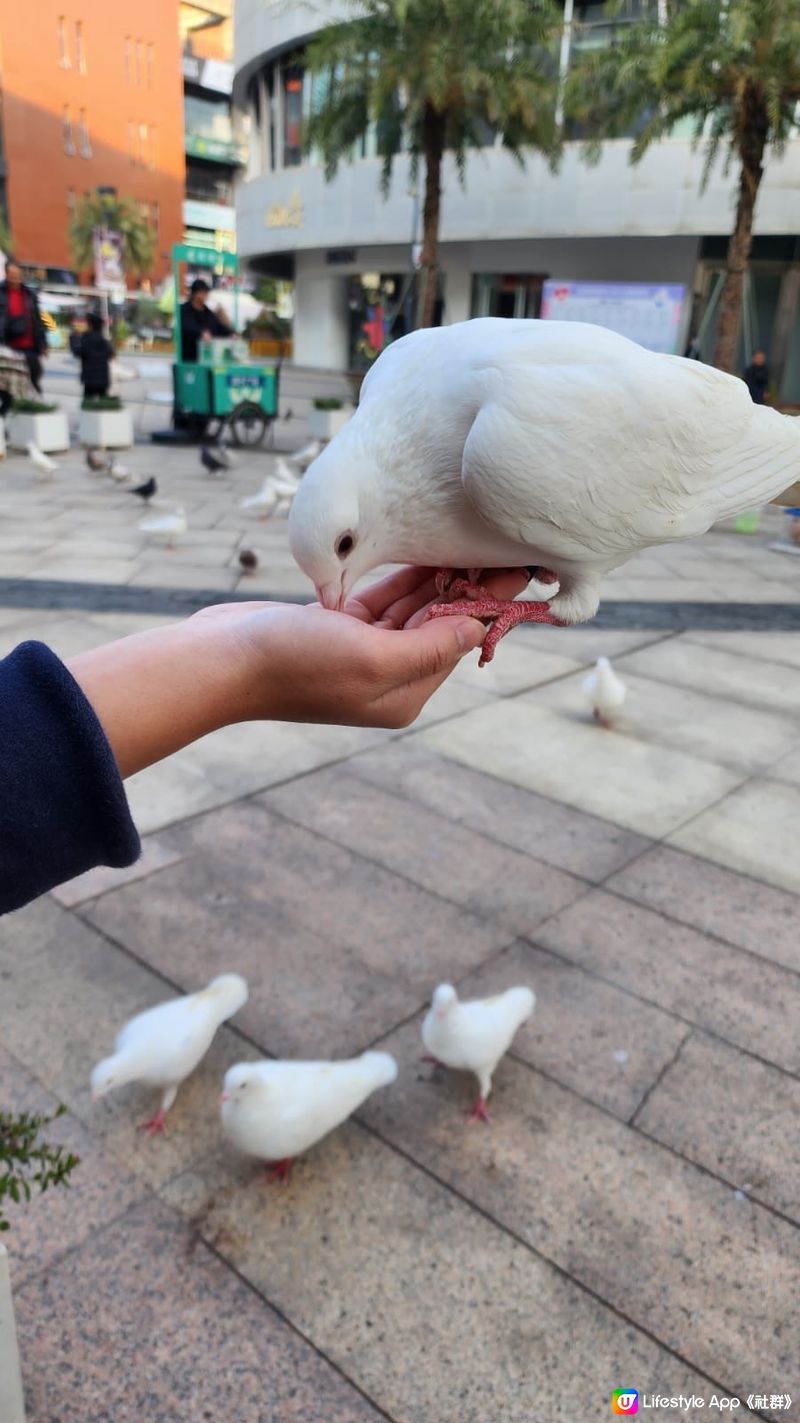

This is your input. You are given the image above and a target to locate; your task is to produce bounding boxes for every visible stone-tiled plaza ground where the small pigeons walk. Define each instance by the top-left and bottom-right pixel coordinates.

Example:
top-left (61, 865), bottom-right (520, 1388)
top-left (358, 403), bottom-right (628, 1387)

top-left (0, 358), bottom-right (800, 1423)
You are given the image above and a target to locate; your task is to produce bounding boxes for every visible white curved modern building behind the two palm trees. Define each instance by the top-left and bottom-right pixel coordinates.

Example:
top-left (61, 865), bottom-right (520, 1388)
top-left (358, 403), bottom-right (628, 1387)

top-left (233, 0), bottom-right (800, 400)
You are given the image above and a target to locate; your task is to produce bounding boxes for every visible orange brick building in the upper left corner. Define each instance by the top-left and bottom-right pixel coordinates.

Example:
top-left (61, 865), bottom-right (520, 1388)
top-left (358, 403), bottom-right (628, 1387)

top-left (0, 0), bottom-right (184, 279)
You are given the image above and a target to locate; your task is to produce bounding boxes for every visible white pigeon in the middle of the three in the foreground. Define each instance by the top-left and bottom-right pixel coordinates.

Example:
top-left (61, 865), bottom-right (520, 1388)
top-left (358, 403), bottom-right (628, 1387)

top-left (219, 1052), bottom-right (397, 1180)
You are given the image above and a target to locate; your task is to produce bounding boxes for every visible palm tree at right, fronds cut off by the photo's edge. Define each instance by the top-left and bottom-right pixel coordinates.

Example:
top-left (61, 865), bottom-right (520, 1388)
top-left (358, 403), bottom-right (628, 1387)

top-left (565, 0), bottom-right (800, 371)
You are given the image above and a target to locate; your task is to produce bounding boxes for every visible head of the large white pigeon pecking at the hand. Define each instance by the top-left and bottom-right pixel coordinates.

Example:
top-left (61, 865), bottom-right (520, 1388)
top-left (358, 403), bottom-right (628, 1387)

top-left (289, 431), bottom-right (389, 610)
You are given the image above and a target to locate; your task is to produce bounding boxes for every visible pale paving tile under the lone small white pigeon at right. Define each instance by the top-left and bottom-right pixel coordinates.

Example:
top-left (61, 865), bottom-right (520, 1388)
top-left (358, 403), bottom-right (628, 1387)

top-left (522, 672), bottom-right (800, 771)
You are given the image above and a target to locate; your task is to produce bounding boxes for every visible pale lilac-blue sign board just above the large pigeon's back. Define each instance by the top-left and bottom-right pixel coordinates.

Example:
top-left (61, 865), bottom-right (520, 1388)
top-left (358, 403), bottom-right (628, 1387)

top-left (541, 282), bottom-right (686, 356)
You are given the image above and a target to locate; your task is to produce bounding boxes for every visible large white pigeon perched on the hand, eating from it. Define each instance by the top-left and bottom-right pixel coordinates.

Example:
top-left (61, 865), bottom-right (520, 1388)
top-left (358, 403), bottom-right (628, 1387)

top-left (289, 317), bottom-right (800, 662)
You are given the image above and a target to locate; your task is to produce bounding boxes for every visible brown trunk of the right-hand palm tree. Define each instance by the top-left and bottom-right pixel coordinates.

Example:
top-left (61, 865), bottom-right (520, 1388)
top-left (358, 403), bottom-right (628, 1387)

top-left (712, 95), bottom-right (769, 371)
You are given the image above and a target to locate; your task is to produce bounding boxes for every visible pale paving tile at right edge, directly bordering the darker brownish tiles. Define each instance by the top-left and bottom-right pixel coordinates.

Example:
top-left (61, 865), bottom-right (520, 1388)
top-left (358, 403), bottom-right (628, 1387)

top-left (669, 781), bottom-right (800, 894)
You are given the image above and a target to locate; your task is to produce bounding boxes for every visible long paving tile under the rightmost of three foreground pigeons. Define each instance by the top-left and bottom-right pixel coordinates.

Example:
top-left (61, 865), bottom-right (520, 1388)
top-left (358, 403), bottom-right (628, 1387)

top-left (355, 1041), bottom-right (800, 1417)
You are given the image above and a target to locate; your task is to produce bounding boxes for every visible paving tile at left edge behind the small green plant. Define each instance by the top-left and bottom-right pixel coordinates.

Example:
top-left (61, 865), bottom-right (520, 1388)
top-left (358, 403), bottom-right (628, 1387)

top-left (0, 1046), bottom-right (145, 1292)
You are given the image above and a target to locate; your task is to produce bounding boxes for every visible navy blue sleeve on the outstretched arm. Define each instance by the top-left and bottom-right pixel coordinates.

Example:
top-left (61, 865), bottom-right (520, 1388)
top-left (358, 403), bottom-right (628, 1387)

top-left (0, 642), bottom-right (141, 914)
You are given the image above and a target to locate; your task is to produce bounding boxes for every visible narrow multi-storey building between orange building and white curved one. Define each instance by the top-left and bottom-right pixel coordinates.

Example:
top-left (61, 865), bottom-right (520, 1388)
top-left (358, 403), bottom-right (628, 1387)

top-left (179, 0), bottom-right (246, 252)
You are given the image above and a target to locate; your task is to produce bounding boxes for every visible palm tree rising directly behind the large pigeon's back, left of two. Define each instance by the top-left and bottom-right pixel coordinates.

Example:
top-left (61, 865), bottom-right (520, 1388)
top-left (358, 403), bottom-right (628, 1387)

top-left (305, 0), bottom-right (562, 326)
